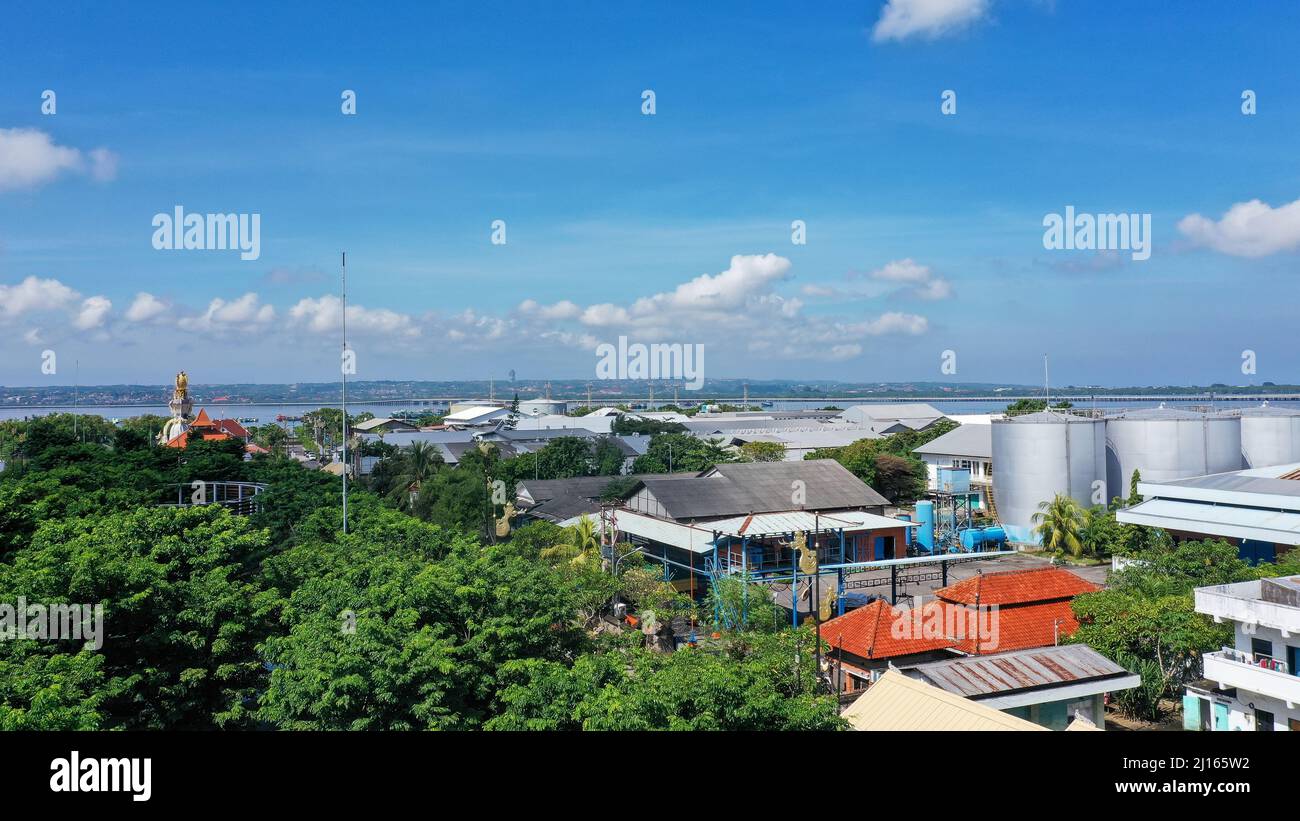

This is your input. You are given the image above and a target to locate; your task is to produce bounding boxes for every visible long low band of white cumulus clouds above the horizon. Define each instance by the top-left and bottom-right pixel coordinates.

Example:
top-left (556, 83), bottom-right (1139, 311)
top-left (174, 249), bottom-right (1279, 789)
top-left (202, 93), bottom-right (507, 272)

top-left (0, 253), bottom-right (946, 361)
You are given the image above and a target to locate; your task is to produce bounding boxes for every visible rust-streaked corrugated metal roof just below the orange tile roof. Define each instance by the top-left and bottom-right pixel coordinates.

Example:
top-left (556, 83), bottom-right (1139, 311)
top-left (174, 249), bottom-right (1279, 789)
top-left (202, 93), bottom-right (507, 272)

top-left (905, 644), bottom-right (1128, 699)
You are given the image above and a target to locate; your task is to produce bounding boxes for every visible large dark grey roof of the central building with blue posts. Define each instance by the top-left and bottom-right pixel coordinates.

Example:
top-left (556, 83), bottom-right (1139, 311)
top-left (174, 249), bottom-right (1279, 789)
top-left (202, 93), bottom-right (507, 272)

top-left (629, 459), bottom-right (889, 521)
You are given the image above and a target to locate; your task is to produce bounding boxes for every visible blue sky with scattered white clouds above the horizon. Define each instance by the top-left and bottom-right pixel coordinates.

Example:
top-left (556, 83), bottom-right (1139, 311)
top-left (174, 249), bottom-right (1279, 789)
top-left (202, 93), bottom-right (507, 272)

top-left (0, 0), bottom-right (1300, 385)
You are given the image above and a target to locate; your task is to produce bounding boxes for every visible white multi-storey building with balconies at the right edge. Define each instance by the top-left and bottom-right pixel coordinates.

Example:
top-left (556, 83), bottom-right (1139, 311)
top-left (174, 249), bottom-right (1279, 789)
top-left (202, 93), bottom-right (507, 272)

top-left (1183, 575), bottom-right (1300, 731)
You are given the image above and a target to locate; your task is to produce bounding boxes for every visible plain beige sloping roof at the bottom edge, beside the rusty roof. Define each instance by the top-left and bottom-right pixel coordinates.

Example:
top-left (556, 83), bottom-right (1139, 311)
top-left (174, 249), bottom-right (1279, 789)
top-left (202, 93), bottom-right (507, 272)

top-left (841, 670), bottom-right (1048, 733)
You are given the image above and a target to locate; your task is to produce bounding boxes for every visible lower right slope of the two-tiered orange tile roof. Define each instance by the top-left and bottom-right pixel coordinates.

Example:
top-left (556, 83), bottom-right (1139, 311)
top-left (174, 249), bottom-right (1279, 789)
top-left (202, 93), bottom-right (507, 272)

top-left (920, 599), bottom-right (1079, 656)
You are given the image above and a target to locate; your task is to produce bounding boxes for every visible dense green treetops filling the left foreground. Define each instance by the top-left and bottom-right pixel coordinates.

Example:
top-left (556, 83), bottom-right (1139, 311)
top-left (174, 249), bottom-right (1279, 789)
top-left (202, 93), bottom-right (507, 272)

top-left (0, 414), bottom-right (839, 730)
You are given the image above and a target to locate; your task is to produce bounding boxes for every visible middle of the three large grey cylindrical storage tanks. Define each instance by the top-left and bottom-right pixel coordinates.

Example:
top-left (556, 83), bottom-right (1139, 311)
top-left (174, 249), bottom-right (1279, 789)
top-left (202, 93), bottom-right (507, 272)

top-left (1106, 405), bottom-right (1242, 498)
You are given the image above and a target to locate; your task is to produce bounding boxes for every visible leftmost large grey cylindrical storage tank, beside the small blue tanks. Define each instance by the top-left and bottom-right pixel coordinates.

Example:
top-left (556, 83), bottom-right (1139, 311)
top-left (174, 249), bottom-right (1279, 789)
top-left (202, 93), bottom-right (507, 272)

top-left (993, 411), bottom-right (1106, 542)
